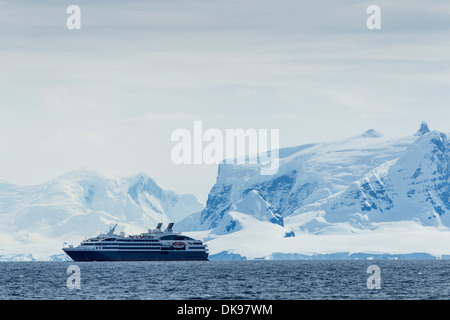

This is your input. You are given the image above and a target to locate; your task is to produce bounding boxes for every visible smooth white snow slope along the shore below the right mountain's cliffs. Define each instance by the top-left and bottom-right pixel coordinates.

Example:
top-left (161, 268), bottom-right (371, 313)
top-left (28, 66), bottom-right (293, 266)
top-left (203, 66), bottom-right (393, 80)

top-left (189, 212), bottom-right (450, 259)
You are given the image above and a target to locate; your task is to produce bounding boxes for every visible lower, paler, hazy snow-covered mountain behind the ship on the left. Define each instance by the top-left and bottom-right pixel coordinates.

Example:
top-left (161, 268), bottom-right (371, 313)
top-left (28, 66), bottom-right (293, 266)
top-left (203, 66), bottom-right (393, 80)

top-left (0, 169), bottom-right (204, 260)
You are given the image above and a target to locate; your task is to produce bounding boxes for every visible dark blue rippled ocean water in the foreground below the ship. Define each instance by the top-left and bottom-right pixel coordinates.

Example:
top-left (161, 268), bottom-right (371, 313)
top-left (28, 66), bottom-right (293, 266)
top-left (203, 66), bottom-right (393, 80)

top-left (0, 260), bottom-right (450, 300)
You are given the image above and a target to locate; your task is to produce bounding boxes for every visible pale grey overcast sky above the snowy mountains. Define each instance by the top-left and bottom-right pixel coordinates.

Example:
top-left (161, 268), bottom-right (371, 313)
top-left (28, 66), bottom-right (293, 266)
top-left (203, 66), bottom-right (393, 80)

top-left (0, 0), bottom-right (450, 200)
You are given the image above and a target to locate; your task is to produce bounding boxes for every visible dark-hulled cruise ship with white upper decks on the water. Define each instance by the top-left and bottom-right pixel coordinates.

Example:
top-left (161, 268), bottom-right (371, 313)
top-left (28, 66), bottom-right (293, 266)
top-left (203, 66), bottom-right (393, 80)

top-left (63, 223), bottom-right (208, 261)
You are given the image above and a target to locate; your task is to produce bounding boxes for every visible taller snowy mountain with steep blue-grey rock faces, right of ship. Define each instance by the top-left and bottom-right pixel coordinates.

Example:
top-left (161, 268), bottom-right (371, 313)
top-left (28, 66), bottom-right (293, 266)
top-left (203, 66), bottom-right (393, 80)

top-left (178, 123), bottom-right (450, 258)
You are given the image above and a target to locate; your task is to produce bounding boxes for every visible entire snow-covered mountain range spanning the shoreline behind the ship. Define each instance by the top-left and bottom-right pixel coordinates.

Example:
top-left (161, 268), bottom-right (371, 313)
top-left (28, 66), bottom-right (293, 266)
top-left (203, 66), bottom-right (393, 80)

top-left (5, 123), bottom-right (450, 260)
